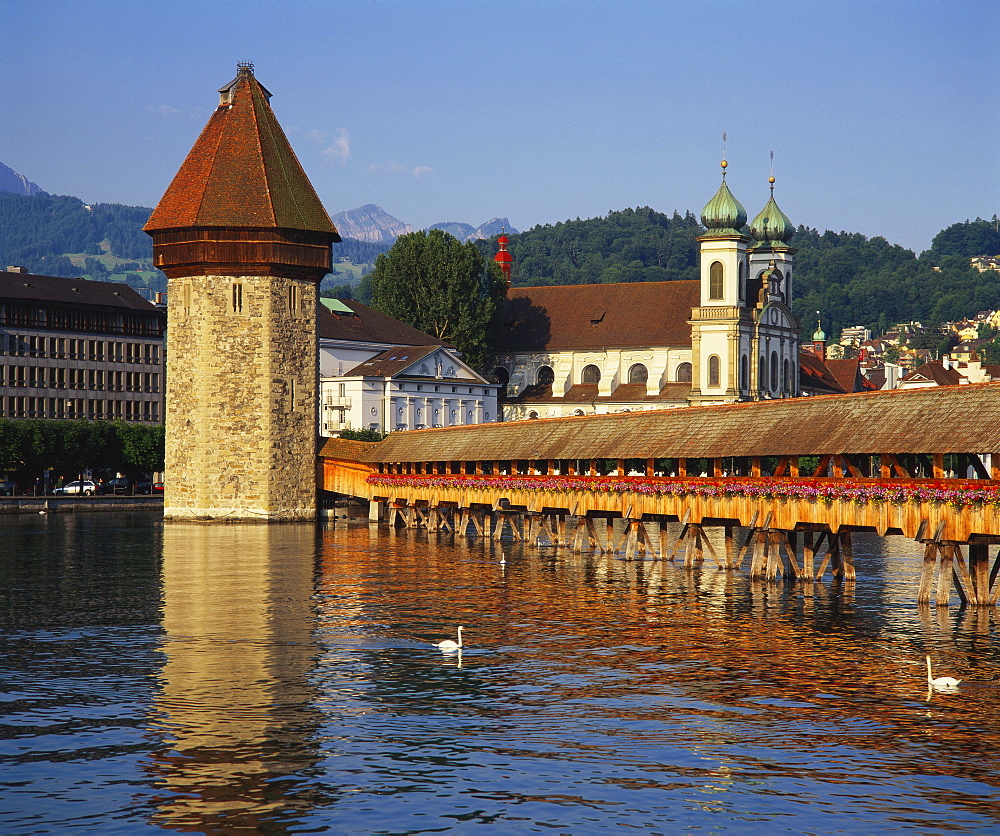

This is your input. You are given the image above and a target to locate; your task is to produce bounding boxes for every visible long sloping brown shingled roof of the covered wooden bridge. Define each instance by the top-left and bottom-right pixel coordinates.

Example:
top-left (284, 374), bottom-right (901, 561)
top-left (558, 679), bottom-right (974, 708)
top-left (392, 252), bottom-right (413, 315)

top-left (361, 383), bottom-right (1000, 462)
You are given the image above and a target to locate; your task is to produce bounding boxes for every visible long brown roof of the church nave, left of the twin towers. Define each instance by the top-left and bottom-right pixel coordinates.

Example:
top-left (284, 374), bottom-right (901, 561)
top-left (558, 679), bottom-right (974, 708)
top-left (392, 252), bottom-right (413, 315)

top-left (498, 281), bottom-right (700, 352)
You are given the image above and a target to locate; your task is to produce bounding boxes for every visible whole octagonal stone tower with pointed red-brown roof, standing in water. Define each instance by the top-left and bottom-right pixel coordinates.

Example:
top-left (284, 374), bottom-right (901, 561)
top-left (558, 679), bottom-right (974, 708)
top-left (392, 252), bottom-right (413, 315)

top-left (145, 64), bottom-right (340, 521)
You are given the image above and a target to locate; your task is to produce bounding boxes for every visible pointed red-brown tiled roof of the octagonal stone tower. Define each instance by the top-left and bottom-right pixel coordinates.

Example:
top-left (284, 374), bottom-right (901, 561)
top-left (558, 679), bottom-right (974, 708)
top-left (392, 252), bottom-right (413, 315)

top-left (145, 64), bottom-right (340, 235)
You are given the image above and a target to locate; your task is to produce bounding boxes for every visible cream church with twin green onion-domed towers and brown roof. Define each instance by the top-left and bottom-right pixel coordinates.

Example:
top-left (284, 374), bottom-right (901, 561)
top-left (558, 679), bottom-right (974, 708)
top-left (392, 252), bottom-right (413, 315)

top-left (494, 161), bottom-right (802, 420)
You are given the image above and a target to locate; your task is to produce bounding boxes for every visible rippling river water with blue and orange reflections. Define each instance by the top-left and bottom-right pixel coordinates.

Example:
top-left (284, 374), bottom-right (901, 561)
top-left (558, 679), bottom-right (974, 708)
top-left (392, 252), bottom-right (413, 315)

top-left (0, 513), bottom-right (1000, 833)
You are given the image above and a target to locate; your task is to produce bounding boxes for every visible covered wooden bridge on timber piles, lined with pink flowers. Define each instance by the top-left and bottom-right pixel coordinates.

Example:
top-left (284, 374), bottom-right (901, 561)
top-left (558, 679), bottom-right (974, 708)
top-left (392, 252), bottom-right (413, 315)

top-left (320, 383), bottom-right (1000, 605)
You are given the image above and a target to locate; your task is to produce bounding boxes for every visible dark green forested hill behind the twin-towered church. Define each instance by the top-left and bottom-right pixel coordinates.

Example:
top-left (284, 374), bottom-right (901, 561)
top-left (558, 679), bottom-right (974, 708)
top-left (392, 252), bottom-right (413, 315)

top-left (478, 207), bottom-right (1000, 334)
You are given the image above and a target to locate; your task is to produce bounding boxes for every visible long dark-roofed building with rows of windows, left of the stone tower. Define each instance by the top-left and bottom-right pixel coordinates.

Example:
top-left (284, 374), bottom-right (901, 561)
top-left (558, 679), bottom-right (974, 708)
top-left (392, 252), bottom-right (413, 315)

top-left (0, 267), bottom-right (166, 424)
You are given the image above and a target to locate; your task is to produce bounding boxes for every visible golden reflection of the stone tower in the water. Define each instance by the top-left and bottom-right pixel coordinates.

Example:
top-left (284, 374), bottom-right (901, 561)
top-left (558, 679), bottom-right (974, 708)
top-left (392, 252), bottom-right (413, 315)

top-left (147, 523), bottom-right (319, 832)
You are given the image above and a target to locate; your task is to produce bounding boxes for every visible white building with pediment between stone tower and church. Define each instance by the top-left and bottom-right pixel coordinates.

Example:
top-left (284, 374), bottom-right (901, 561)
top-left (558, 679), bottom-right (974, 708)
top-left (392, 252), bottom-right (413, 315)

top-left (318, 299), bottom-right (500, 436)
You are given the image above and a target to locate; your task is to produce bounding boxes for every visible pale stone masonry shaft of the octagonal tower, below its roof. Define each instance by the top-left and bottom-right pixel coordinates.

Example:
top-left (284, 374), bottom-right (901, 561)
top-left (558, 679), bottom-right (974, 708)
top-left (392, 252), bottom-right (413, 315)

top-left (164, 276), bottom-right (317, 520)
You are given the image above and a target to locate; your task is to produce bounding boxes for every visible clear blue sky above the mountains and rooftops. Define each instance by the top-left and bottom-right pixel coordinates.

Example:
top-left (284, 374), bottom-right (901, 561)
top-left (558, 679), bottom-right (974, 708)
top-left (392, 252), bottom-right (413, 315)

top-left (0, 0), bottom-right (1000, 252)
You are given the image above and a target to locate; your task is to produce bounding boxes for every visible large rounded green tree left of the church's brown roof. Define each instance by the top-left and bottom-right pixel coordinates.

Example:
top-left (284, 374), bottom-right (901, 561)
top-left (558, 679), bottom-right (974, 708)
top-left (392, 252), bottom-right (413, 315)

top-left (371, 229), bottom-right (505, 367)
